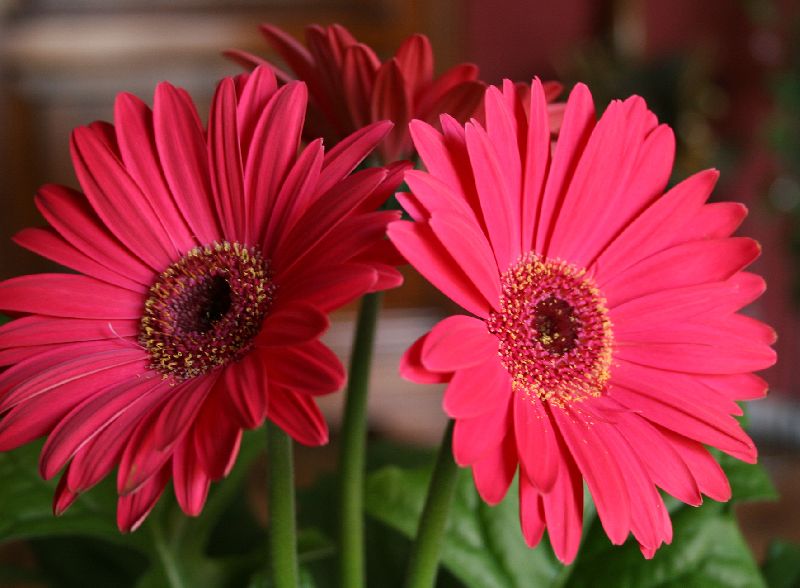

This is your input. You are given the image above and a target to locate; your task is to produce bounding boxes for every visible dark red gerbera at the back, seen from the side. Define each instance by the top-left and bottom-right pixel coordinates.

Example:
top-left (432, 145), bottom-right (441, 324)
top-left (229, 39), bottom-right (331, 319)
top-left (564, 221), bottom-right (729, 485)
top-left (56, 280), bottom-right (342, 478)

top-left (227, 25), bottom-right (484, 162)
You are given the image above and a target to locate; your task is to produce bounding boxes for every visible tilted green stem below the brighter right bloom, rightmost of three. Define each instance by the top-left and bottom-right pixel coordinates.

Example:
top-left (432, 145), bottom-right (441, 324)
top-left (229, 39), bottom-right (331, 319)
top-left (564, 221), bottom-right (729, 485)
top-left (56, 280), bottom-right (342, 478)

top-left (406, 421), bottom-right (458, 588)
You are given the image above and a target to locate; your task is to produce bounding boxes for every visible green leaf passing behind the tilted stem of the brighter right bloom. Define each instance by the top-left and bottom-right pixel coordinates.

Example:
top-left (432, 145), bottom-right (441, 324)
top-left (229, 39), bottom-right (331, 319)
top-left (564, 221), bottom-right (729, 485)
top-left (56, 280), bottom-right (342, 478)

top-left (366, 467), bottom-right (564, 588)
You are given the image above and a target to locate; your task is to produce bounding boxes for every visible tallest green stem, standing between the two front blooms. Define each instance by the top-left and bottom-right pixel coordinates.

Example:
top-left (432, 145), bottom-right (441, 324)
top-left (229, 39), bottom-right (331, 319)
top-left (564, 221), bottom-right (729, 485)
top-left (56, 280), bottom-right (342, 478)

top-left (339, 294), bottom-right (381, 588)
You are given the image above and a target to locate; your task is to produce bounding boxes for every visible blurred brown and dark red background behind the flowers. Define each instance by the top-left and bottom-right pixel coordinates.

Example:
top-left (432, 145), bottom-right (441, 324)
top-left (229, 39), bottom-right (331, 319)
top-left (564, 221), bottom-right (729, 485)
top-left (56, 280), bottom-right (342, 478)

top-left (0, 0), bottom-right (800, 580)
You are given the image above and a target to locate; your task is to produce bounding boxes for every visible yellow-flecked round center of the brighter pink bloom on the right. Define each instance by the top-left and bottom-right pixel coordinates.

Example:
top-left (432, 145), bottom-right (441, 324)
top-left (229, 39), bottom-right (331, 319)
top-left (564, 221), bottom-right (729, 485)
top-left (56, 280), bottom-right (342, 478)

top-left (487, 252), bottom-right (613, 406)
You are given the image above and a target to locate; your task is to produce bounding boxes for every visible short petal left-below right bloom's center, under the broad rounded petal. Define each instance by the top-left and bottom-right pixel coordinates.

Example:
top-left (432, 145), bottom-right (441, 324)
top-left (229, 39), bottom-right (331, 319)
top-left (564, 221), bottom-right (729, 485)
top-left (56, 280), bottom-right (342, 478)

top-left (440, 352), bottom-right (512, 419)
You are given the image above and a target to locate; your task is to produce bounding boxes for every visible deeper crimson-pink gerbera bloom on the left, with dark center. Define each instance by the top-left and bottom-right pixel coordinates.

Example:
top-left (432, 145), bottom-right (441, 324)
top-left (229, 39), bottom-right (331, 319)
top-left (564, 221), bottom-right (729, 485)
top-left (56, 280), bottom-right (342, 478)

top-left (0, 68), bottom-right (402, 531)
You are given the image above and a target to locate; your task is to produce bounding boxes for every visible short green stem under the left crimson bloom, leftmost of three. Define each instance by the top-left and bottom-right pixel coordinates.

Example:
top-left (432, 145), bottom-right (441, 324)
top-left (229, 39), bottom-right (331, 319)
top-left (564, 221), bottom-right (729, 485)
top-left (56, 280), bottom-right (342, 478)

top-left (267, 422), bottom-right (299, 588)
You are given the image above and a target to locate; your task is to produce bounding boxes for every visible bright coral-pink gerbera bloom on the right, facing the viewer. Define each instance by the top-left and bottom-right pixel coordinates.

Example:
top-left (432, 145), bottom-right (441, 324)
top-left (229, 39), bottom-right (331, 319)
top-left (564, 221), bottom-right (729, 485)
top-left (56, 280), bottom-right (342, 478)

top-left (389, 80), bottom-right (775, 563)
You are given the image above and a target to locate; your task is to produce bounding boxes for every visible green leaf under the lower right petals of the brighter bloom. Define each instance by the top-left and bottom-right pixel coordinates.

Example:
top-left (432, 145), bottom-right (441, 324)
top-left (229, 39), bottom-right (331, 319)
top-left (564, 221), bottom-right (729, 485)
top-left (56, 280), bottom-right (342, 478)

top-left (565, 503), bottom-right (765, 588)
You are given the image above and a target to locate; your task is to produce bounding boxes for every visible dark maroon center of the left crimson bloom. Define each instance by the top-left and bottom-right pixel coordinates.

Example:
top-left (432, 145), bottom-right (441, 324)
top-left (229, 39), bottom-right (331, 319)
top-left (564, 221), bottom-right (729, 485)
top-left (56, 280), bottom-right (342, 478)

top-left (139, 241), bottom-right (275, 381)
